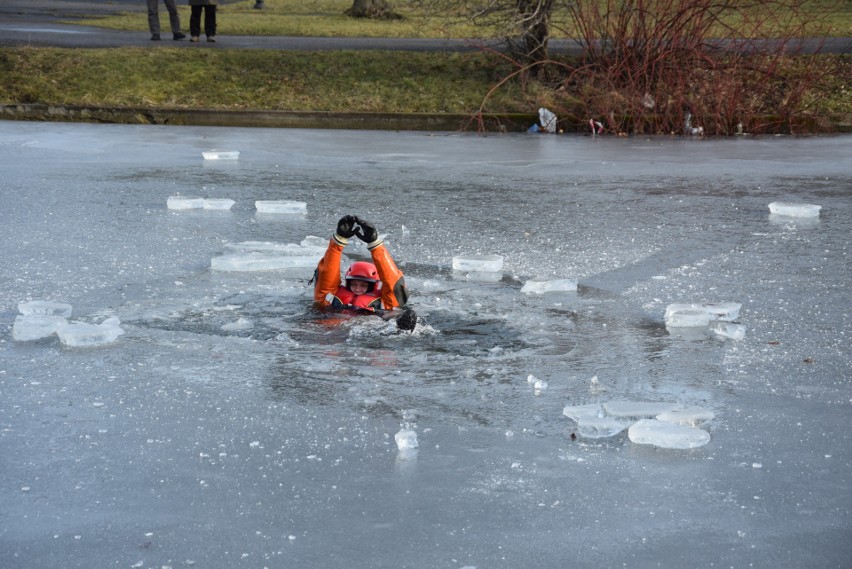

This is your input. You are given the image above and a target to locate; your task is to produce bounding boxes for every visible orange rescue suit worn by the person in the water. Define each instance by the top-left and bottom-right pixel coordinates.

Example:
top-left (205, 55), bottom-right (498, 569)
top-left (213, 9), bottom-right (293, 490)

top-left (314, 237), bottom-right (408, 310)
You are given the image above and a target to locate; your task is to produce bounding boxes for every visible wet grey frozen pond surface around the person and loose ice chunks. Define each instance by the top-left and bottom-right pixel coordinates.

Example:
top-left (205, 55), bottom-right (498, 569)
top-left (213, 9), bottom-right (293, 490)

top-left (0, 122), bottom-right (852, 569)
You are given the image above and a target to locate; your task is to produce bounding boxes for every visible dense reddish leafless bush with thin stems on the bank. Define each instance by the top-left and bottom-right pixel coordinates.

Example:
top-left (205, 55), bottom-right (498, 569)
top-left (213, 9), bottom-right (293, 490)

top-left (559, 0), bottom-right (831, 135)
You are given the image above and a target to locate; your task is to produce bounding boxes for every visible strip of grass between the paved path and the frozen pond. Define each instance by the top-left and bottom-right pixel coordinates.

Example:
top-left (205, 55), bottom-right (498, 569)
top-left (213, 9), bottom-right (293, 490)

top-left (0, 47), bottom-right (530, 113)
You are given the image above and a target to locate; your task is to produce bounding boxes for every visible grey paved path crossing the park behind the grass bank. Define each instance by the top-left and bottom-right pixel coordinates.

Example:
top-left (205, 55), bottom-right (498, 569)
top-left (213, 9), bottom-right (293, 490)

top-left (0, 0), bottom-right (852, 55)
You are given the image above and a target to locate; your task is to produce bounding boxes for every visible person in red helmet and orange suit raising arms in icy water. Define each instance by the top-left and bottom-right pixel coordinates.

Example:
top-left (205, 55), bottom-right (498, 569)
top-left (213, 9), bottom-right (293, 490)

top-left (314, 215), bottom-right (417, 330)
